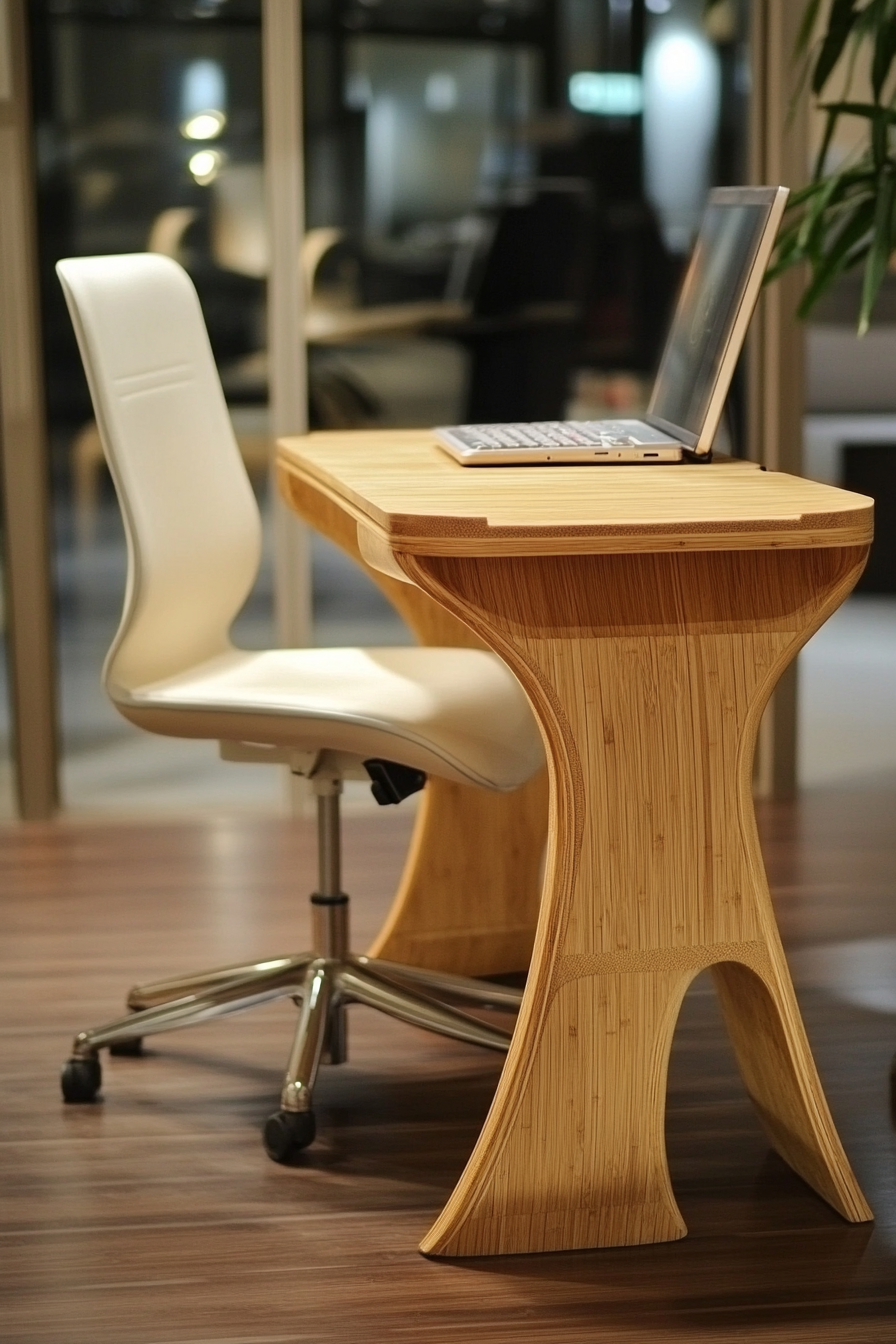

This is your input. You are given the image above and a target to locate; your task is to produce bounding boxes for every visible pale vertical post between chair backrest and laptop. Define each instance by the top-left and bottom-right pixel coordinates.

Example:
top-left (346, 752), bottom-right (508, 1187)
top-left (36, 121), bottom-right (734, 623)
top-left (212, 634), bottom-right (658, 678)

top-left (262, 0), bottom-right (312, 646)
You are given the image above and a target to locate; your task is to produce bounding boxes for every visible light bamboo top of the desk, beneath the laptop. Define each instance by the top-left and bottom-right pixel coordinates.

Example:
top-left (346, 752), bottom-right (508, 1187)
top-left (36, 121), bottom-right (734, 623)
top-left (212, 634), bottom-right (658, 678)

top-left (278, 430), bottom-right (873, 555)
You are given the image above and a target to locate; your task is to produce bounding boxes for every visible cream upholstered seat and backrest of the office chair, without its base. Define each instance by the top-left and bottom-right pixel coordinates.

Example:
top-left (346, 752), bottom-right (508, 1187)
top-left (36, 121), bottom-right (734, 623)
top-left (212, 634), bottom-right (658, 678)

top-left (56, 254), bottom-right (543, 789)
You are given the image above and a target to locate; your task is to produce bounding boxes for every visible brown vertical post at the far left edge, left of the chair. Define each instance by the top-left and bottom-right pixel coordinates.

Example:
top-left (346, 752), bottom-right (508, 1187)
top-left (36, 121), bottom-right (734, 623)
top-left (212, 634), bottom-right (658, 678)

top-left (0, 0), bottom-right (59, 820)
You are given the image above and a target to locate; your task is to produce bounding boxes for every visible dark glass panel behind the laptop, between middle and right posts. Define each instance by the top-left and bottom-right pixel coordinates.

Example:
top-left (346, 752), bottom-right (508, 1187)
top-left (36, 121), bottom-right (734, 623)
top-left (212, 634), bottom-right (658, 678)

top-left (304, 0), bottom-right (748, 439)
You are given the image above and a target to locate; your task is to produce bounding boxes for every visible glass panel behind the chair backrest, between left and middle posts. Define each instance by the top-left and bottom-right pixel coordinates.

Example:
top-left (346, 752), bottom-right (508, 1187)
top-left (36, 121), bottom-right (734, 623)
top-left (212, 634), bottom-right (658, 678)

top-left (31, 0), bottom-right (279, 812)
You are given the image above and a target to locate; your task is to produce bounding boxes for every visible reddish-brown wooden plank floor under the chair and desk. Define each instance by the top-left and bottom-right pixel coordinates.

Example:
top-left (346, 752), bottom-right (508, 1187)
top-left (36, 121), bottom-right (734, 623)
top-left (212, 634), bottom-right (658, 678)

top-left (0, 778), bottom-right (896, 1344)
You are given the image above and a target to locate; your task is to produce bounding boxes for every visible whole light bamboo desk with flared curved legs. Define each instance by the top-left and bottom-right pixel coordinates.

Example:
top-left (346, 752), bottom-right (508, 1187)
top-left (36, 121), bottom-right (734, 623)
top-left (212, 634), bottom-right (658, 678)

top-left (278, 430), bottom-right (872, 1255)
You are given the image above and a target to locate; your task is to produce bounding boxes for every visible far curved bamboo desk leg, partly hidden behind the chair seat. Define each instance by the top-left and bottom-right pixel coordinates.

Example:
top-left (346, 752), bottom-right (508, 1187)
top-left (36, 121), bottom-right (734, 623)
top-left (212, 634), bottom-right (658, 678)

top-left (279, 473), bottom-right (548, 976)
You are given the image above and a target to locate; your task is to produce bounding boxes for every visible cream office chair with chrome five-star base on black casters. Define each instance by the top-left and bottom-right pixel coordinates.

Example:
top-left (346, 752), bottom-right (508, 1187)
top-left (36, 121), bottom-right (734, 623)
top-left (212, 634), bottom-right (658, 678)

top-left (56, 254), bottom-right (543, 1161)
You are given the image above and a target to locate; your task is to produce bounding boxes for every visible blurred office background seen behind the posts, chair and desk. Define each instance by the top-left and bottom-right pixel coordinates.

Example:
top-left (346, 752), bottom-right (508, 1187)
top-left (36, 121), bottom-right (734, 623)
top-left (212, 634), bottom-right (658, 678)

top-left (0, 0), bottom-right (896, 814)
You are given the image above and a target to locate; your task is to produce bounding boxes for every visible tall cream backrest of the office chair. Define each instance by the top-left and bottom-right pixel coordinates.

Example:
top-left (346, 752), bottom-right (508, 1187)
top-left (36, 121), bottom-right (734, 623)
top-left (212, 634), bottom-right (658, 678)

top-left (56, 253), bottom-right (261, 699)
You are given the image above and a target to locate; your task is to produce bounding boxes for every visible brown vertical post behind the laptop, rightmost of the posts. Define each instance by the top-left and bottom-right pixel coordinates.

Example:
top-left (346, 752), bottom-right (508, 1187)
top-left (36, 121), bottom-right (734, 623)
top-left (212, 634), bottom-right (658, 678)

top-left (747, 0), bottom-right (809, 798)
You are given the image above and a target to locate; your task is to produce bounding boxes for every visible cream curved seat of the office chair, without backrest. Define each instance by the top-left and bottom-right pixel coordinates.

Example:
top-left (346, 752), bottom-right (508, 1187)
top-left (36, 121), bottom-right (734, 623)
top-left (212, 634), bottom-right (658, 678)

top-left (114, 648), bottom-right (540, 789)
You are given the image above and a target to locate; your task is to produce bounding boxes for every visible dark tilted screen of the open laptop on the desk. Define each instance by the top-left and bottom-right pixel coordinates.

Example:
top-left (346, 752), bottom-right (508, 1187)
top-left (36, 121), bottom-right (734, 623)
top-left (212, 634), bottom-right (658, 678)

top-left (647, 194), bottom-right (771, 435)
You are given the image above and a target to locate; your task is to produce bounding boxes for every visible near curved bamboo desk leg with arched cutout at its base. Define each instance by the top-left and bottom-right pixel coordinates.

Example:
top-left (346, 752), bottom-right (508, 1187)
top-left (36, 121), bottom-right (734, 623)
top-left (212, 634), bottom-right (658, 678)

top-left (399, 548), bottom-right (870, 1255)
